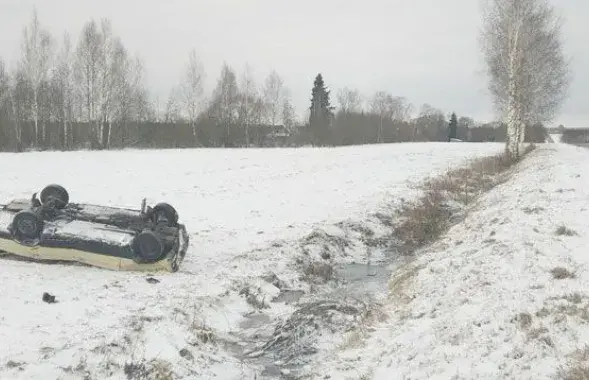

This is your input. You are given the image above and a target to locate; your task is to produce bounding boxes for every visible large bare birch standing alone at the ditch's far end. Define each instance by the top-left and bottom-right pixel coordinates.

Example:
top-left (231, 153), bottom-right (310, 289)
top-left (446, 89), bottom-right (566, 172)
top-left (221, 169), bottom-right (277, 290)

top-left (480, 0), bottom-right (570, 158)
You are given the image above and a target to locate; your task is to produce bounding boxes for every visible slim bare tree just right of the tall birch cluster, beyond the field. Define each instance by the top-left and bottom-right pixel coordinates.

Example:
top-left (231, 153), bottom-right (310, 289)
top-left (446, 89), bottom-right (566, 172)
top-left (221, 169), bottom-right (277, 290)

top-left (180, 49), bottom-right (205, 143)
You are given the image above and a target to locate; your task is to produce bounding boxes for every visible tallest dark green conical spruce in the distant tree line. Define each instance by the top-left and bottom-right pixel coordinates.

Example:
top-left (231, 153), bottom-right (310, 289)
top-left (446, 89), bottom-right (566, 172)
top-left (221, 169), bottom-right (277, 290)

top-left (309, 73), bottom-right (334, 146)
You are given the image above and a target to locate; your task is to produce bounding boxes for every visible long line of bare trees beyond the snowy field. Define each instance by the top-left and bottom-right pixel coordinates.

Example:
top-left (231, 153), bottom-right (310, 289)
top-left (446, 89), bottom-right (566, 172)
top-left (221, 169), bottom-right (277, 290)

top-left (0, 11), bottom-right (545, 151)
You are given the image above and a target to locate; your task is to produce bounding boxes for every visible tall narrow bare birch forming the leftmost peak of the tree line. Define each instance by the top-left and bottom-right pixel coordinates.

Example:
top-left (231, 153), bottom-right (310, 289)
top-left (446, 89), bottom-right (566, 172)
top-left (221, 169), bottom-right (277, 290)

top-left (21, 10), bottom-right (54, 146)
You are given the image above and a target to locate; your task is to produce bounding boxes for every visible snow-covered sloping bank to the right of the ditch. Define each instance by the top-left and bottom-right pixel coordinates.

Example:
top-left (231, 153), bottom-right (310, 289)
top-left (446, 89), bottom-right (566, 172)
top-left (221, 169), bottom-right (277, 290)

top-left (310, 144), bottom-right (589, 380)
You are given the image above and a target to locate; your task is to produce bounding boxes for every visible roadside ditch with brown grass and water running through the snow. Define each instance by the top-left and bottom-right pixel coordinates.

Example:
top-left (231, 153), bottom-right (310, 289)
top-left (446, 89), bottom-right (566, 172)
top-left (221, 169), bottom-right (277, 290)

top-left (225, 145), bottom-right (535, 379)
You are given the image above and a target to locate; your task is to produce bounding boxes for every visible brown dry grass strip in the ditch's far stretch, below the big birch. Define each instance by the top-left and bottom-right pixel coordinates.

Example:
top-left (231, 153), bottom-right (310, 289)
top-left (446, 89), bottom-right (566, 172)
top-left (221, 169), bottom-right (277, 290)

top-left (394, 147), bottom-right (533, 254)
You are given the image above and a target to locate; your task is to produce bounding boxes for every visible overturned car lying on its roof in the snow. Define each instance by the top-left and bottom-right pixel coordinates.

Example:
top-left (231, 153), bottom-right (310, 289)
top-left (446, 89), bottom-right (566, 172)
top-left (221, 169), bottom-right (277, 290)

top-left (0, 185), bottom-right (189, 272)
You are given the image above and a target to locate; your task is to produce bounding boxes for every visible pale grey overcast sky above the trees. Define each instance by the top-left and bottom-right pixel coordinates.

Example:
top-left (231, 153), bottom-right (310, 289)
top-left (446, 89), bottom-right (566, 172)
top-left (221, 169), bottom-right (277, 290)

top-left (0, 0), bottom-right (589, 126)
